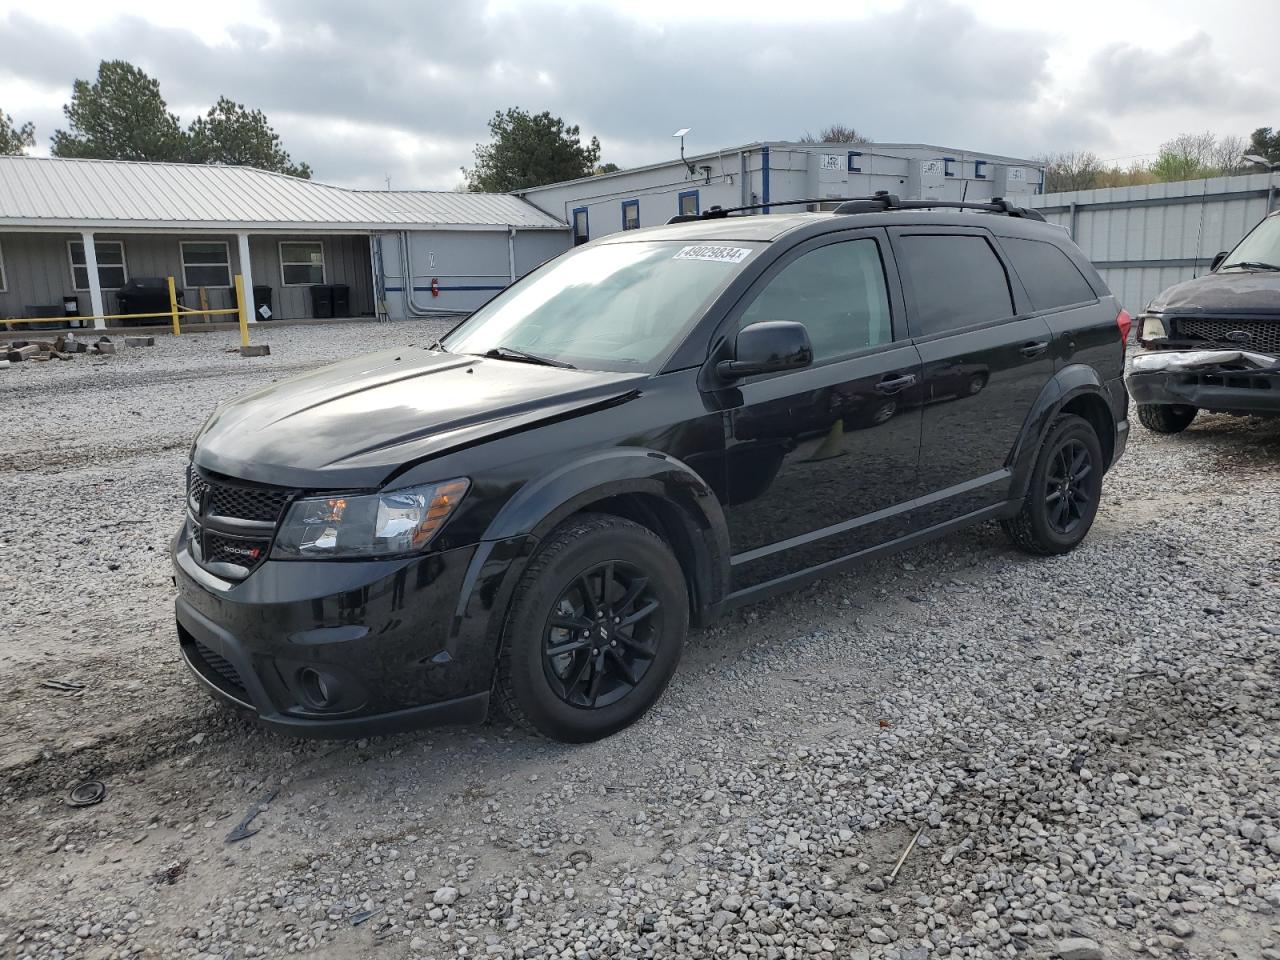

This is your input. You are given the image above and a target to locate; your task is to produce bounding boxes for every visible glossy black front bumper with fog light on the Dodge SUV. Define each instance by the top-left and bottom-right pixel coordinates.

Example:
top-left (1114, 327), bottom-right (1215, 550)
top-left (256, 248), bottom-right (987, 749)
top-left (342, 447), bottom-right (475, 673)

top-left (172, 532), bottom-right (504, 737)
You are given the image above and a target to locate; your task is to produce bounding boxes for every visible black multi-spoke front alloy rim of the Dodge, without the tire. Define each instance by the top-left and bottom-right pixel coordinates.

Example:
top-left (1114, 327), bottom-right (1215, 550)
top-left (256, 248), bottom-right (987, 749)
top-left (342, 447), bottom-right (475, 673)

top-left (543, 561), bottom-right (663, 710)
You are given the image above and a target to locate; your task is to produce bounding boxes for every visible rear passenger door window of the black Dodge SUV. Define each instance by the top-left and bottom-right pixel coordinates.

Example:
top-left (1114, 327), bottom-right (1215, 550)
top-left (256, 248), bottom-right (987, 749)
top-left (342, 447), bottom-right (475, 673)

top-left (896, 234), bottom-right (1014, 337)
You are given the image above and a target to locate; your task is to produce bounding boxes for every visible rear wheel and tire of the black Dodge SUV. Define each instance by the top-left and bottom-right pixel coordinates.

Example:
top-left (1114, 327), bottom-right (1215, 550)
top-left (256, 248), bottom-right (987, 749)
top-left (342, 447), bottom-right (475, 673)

top-left (1001, 413), bottom-right (1103, 557)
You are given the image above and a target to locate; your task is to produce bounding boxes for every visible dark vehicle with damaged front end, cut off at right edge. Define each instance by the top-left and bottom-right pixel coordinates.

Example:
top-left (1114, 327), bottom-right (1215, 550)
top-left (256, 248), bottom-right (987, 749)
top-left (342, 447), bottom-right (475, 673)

top-left (1128, 211), bottom-right (1280, 434)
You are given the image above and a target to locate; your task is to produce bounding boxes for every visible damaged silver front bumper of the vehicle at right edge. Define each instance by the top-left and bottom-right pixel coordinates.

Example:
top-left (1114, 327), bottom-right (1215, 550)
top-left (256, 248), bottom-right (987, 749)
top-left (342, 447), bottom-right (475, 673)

top-left (1125, 351), bottom-right (1280, 416)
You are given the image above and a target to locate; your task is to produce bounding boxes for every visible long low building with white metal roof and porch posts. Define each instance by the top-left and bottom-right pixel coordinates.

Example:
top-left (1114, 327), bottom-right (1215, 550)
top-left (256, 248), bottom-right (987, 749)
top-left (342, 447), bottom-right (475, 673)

top-left (0, 156), bottom-right (568, 320)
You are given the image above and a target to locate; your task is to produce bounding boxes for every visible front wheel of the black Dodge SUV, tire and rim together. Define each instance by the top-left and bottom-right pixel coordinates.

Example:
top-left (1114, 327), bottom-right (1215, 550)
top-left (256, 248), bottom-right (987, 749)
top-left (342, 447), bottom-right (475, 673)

top-left (495, 513), bottom-right (689, 744)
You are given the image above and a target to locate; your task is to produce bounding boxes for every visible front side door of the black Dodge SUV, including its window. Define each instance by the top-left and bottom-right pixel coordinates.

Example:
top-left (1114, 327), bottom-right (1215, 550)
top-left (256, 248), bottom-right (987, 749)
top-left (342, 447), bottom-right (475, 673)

top-left (726, 229), bottom-right (920, 590)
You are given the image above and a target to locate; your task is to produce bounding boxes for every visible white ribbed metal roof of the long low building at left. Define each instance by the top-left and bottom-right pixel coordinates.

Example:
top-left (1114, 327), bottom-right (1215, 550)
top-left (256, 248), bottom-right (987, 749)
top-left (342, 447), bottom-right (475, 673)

top-left (0, 156), bottom-right (566, 230)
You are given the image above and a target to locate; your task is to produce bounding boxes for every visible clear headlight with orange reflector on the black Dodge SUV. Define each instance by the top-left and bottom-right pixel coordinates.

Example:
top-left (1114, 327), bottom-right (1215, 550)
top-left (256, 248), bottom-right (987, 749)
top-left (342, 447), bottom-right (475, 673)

top-left (271, 479), bottom-right (471, 559)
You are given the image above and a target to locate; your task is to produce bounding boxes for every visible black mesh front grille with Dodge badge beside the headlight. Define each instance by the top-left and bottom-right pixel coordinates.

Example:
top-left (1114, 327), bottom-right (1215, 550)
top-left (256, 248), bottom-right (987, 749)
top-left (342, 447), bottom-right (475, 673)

top-left (187, 466), bottom-right (294, 580)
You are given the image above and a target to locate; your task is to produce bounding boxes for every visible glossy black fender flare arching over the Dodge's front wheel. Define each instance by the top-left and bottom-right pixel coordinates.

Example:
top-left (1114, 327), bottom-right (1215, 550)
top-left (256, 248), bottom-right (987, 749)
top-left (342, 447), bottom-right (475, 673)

top-left (453, 447), bottom-right (730, 649)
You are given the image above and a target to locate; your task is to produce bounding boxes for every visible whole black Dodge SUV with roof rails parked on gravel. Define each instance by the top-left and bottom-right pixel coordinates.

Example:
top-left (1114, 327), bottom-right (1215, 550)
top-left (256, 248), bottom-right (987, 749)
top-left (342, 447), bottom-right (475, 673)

top-left (173, 197), bottom-right (1129, 741)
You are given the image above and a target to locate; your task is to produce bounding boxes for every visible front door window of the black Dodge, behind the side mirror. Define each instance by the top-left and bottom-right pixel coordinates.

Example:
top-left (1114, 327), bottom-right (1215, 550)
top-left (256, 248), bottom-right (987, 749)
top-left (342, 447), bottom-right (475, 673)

top-left (741, 239), bottom-right (893, 360)
